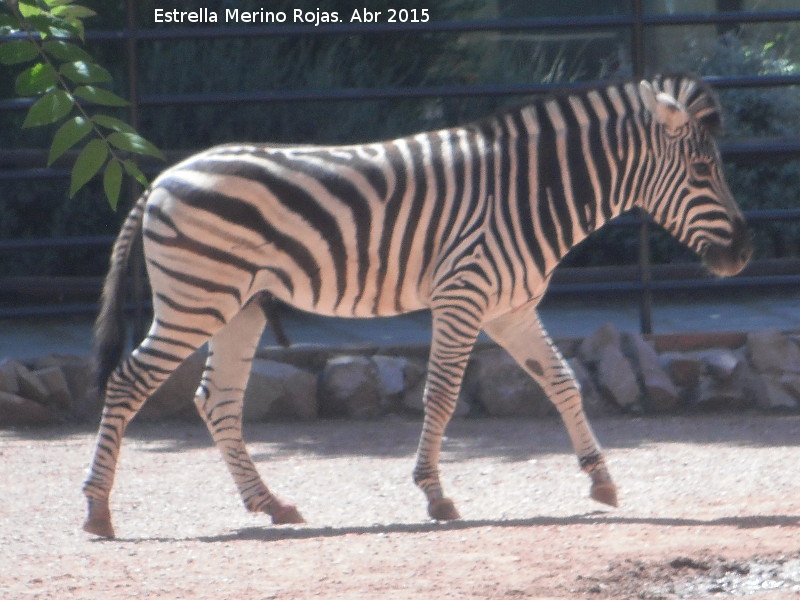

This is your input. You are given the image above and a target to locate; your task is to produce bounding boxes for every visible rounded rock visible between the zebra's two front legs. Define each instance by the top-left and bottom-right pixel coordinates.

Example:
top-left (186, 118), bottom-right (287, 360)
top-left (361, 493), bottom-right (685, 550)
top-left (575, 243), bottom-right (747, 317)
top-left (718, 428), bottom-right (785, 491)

top-left (464, 348), bottom-right (555, 417)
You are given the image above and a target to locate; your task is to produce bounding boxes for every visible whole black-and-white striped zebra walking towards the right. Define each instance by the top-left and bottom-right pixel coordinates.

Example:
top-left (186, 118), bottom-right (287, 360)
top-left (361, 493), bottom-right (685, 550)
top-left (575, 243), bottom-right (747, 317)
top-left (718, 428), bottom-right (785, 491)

top-left (83, 74), bottom-right (752, 538)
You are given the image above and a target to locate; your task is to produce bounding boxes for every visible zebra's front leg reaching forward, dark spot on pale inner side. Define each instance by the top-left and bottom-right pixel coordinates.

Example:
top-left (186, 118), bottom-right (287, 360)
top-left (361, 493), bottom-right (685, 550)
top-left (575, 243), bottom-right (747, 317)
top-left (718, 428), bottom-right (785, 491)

top-left (484, 302), bottom-right (617, 506)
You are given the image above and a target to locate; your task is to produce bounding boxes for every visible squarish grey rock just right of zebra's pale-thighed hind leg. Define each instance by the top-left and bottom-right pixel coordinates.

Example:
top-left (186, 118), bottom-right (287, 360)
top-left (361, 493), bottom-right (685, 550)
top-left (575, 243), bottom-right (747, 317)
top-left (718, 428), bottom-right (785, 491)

top-left (243, 358), bottom-right (318, 422)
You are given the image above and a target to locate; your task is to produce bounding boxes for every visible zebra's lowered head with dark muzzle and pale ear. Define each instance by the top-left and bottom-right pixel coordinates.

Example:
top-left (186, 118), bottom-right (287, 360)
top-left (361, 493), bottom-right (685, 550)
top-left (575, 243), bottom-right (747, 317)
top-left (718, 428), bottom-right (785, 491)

top-left (639, 76), bottom-right (752, 276)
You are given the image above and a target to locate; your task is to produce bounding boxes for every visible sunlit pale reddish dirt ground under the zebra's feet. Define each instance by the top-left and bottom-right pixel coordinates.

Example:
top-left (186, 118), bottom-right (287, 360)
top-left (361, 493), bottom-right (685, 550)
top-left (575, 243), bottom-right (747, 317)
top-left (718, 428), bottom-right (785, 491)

top-left (0, 414), bottom-right (800, 600)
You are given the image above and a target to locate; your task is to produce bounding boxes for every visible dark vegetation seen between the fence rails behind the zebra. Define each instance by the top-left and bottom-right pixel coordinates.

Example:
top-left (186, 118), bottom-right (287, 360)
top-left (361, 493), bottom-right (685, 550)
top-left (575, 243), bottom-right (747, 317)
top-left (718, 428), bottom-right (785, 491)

top-left (0, 0), bottom-right (800, 276)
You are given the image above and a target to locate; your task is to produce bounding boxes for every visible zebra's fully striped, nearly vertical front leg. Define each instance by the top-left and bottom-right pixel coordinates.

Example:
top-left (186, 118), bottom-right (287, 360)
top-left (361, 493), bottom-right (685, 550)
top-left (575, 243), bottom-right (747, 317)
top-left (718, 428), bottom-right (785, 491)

top-left (414, 307), bottom-right (480, 521)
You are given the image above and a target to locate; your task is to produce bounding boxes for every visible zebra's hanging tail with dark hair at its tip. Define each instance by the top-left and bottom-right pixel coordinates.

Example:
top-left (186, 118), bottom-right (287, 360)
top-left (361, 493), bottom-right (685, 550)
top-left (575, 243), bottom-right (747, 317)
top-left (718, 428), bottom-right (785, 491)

top-left (94, 189), bottom-right (150, 394)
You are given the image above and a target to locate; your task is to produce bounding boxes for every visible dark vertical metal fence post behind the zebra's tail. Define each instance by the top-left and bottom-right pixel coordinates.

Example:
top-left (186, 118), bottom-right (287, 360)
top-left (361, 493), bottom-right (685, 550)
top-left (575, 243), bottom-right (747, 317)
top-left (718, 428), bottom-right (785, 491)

top-left (125, 0), bottom-right (146, 346)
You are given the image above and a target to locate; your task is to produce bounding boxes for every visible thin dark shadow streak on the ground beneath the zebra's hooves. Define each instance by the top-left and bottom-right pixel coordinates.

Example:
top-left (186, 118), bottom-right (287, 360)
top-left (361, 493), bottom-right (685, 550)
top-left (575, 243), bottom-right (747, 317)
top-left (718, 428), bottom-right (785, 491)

top-left (109, 511), bottom-right (800, 544)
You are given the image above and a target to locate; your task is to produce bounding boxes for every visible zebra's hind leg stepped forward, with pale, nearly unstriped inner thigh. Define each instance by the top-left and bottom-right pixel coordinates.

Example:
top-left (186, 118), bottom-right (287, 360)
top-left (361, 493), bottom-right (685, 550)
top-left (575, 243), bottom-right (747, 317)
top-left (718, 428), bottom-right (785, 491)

top-left (194, 299), bottom-right (304, 524)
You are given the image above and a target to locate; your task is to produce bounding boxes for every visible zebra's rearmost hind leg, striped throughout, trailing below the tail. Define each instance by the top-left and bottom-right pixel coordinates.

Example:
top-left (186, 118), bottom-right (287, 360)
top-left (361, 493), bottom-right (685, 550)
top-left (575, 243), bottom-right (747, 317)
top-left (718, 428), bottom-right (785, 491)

top-left (83, 319), bottom-right (208, 538)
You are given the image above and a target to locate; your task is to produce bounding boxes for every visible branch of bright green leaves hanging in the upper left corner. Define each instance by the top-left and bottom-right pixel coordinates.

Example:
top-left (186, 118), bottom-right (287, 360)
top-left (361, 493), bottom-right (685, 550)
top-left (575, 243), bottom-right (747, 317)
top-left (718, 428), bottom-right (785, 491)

top-left (0, 0), bottom-right (161, 208)
